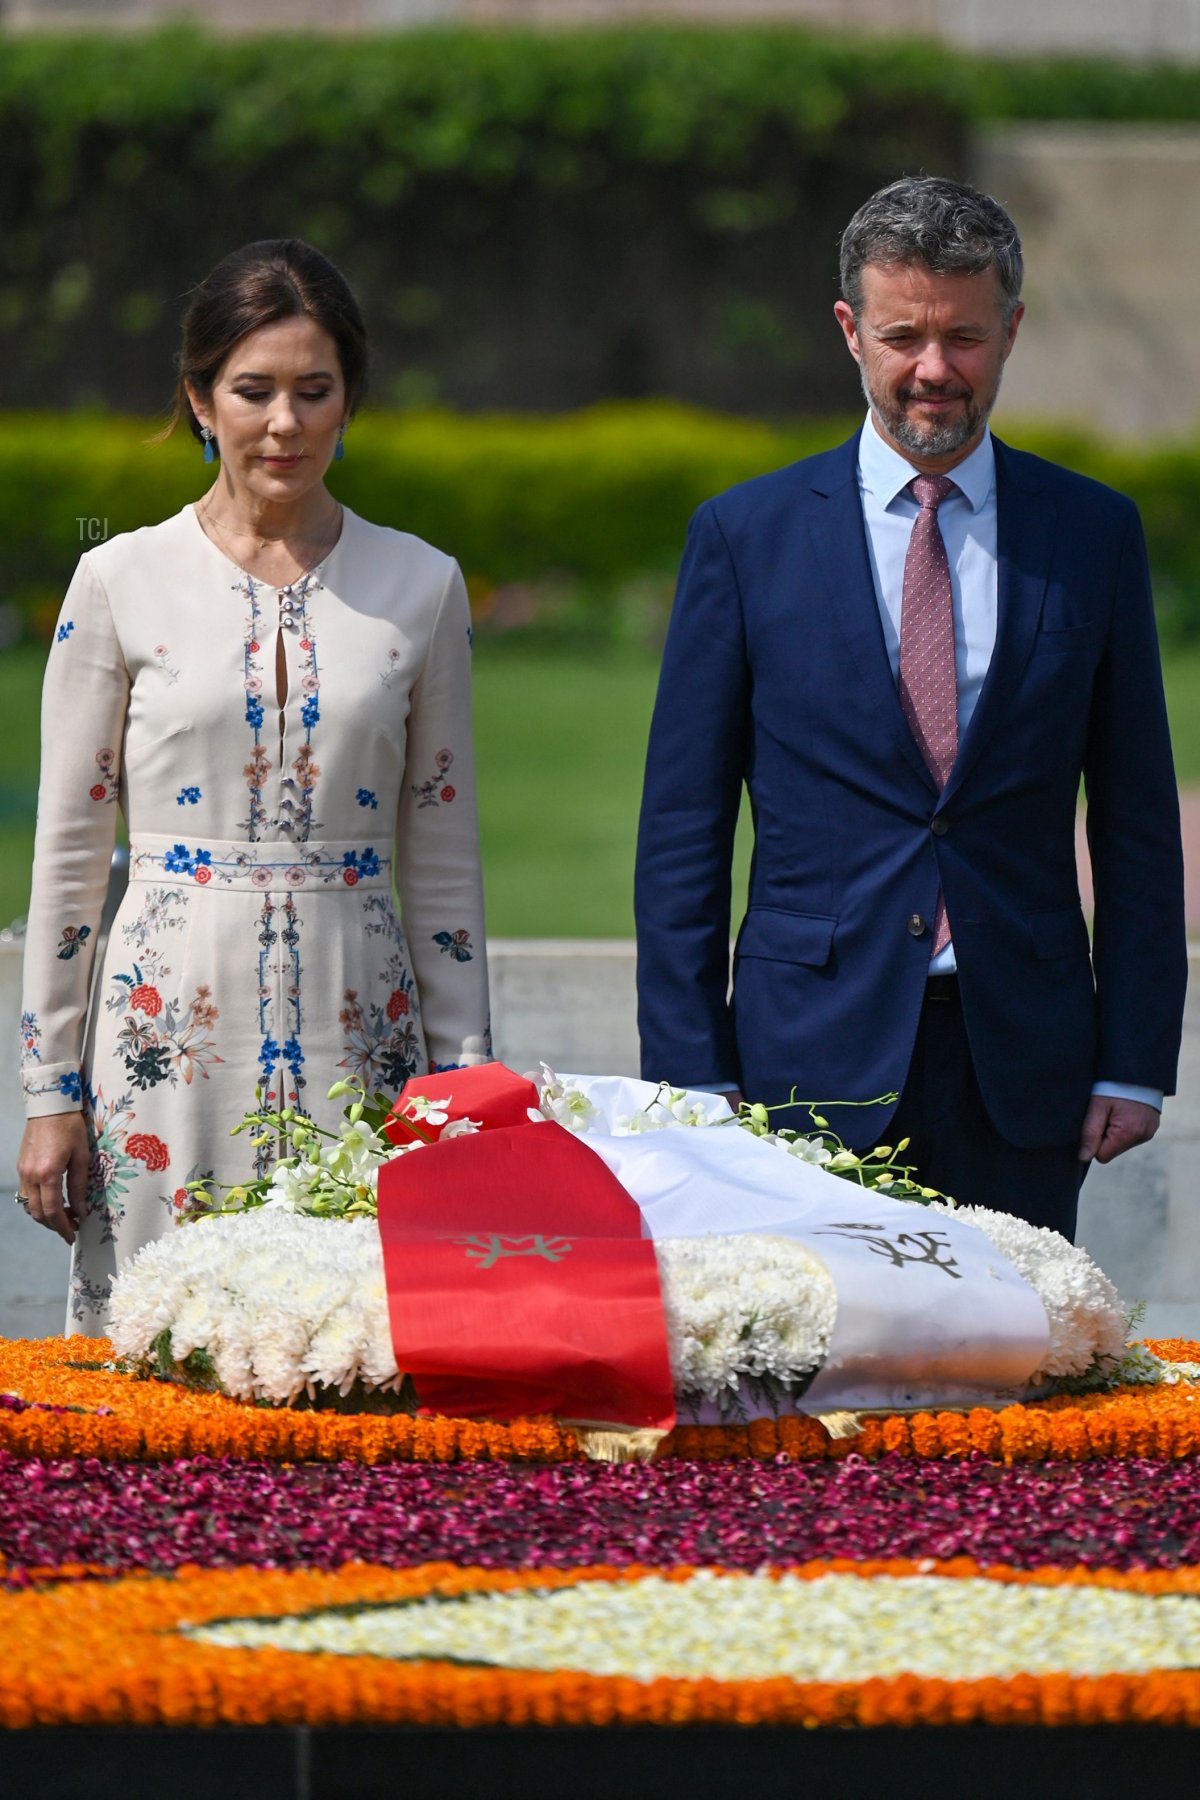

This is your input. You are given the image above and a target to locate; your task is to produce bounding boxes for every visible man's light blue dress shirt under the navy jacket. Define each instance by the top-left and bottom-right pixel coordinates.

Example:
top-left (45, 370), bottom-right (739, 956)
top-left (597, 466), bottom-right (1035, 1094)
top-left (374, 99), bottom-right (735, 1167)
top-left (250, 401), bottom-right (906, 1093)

top-left (858, 414), bottom-right (1162, 1109)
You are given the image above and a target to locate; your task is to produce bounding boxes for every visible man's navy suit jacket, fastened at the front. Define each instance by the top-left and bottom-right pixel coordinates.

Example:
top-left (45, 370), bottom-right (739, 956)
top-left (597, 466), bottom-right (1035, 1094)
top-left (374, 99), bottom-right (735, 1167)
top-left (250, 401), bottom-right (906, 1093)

top-left (635, 437), bottom-right (1187, 1147)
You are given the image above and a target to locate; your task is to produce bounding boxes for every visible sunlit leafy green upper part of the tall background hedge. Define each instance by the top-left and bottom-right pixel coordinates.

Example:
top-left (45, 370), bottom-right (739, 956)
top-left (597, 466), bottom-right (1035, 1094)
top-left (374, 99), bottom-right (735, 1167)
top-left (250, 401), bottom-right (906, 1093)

top-left (0, 25), bottom-right (1200, 179)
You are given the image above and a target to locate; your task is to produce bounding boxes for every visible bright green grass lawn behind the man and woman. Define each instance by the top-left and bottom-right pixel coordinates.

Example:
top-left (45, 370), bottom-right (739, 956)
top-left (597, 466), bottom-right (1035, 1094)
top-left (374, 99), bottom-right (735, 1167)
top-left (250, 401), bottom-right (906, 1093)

top-left (0, 637), bottom-right (1200, 938)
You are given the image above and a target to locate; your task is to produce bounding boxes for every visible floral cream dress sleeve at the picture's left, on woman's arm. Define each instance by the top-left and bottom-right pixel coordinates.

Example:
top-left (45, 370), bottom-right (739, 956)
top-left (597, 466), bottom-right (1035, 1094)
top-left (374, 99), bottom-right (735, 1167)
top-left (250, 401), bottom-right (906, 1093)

top-left (22, 556), bottom-right (130, 1118)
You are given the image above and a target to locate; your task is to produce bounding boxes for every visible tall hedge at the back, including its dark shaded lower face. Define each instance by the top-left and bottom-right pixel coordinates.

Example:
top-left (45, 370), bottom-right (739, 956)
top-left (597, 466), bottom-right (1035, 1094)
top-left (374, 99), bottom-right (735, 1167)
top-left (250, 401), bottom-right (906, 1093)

top-left (14, 25), bottom-right (1200, 416)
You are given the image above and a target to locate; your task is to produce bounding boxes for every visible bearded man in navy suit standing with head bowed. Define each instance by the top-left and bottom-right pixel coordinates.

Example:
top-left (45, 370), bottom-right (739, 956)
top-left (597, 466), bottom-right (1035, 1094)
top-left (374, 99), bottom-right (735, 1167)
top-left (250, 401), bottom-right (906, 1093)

top-left (637, 176), bottom-right (1187, 1235)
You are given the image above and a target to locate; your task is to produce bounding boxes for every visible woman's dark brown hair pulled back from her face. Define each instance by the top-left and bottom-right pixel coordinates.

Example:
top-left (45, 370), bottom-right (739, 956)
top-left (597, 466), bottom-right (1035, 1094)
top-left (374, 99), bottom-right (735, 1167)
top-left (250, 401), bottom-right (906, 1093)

top-left (169, 238), bottom-right (367, 437)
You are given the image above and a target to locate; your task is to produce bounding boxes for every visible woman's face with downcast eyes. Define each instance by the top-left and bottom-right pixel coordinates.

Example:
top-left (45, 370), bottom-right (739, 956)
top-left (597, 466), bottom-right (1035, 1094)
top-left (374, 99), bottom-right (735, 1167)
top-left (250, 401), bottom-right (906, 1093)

top-left (187, 317), bottom-right (345, 504)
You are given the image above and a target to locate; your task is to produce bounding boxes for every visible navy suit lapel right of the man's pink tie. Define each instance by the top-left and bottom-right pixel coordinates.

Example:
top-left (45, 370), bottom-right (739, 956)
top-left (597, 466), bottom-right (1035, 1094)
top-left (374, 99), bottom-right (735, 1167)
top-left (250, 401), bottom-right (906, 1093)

top-left (943, 439), bottom-right (1054, 803)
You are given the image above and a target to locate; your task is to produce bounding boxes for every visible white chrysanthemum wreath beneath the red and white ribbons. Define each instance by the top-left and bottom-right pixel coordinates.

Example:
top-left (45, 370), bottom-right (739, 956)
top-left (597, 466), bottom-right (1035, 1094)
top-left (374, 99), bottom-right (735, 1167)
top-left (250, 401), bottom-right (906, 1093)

top-left (112, 1206), bottom-right (1137, 1402)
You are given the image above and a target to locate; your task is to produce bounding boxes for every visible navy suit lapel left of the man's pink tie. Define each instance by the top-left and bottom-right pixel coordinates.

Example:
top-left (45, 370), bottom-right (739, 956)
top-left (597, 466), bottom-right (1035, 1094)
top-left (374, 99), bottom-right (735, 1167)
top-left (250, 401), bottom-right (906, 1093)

top-left (810, 436), bottom-right (937, 794)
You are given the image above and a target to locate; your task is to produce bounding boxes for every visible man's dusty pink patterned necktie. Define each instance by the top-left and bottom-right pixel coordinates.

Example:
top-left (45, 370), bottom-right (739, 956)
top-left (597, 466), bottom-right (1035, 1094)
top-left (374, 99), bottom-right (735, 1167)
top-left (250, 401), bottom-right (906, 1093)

top-left (900, 475), bottom-right (959, 956)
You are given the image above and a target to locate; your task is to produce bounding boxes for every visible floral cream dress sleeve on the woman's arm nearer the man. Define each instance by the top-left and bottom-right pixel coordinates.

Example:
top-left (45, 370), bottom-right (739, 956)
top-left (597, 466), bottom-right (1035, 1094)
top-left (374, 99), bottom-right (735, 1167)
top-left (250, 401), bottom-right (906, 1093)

top-left (396, 563), bottom-right (491, 1069)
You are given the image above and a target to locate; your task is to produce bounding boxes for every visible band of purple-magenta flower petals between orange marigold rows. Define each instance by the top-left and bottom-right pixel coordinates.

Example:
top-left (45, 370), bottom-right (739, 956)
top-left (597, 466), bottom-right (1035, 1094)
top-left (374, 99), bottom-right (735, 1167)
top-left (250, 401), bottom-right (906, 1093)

top-left (0, 1453), bottom-right (1200, 1580)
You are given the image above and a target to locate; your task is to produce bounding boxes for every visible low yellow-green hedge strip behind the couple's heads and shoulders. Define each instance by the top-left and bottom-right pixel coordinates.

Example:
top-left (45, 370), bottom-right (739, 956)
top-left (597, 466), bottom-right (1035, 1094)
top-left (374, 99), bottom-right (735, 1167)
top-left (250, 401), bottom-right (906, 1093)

top-left (0, 401), bottom-right (1200, 637)
